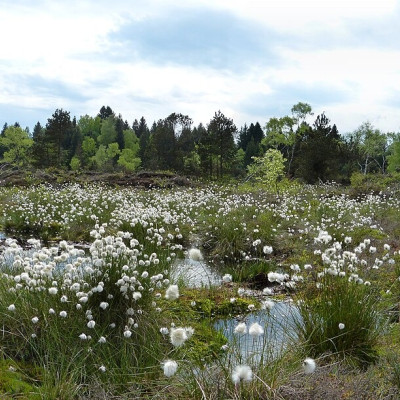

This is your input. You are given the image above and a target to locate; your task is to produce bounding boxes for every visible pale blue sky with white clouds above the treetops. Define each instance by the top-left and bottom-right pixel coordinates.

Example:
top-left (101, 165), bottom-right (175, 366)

top-left (0, 0), bottom-right (400, 134)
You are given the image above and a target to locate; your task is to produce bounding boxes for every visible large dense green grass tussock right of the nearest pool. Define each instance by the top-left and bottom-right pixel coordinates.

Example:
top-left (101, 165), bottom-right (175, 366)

top-left (296, 275), bottom-right (383, 365)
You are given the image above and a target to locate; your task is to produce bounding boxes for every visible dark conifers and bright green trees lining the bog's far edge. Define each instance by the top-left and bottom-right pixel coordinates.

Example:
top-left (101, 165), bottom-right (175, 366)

top-left (0, 102), bottom-right (400, 183)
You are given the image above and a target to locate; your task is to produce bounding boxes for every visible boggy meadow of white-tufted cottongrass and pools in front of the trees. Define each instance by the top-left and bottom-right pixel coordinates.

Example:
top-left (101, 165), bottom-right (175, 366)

top-left (0, 182), bottom-right (400, 399)
